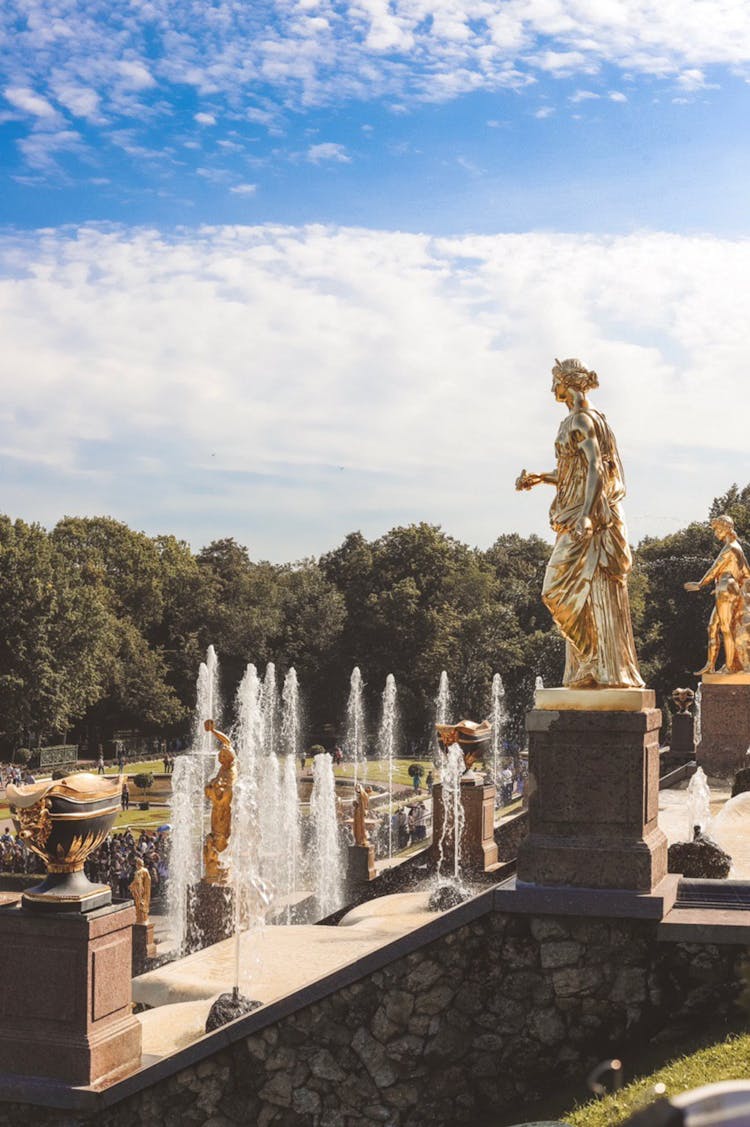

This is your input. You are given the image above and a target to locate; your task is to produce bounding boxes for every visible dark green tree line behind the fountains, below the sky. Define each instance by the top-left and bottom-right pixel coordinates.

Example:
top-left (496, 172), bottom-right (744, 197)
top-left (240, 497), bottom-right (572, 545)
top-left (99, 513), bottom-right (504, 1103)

top-left (0, 485), bottom-right (750, 757)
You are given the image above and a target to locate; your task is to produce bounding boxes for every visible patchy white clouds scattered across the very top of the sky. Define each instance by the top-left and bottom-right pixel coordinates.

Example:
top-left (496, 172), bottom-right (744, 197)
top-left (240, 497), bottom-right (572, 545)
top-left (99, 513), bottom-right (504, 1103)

top-left (0, 0), bottom-right (750, 180)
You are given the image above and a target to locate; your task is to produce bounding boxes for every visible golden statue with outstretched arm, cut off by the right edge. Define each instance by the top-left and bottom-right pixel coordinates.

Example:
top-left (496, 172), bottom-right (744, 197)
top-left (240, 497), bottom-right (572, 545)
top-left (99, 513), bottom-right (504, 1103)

top-left (685, 513), bottom-right (750, 676)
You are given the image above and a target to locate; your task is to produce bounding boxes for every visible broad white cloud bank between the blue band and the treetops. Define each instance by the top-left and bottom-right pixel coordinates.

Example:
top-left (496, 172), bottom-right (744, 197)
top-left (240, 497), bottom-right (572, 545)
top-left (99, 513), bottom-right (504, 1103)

top-left (0, 227), bottom-right (750, 558)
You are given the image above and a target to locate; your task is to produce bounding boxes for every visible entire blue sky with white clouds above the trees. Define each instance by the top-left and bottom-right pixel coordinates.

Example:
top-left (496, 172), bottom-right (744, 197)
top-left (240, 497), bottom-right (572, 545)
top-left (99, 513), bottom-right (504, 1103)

top-left (0, 0), bottom-right (750, 559)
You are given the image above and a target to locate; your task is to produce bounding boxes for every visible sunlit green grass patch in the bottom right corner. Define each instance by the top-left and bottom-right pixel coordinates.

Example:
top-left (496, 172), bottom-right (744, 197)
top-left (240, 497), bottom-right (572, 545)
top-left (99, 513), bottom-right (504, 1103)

top-left (562, 1033), bottom-right (750, 1127)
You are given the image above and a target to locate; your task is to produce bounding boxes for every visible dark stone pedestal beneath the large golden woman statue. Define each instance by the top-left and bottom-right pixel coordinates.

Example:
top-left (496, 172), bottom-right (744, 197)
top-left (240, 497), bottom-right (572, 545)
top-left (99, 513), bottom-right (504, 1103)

top-left (518, 708), bottom-right (667, 891)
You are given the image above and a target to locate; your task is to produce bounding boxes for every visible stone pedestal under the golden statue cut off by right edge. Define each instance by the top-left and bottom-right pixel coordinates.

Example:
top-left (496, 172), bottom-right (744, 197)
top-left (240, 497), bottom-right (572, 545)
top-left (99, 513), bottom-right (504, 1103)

top-left (696, 674), bottom-right (750, 779)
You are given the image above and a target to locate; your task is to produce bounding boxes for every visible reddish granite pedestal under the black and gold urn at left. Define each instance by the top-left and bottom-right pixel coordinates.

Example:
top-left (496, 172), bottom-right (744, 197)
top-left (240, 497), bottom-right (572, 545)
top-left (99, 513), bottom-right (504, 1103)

top-left (0, 904), bottom-right (141, 1085)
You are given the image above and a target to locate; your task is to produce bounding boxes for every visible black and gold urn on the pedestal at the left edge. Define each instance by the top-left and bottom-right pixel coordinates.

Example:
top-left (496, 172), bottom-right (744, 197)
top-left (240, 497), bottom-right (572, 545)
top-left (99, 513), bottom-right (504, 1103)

top-left (7, 772), bottom-right (122, 912)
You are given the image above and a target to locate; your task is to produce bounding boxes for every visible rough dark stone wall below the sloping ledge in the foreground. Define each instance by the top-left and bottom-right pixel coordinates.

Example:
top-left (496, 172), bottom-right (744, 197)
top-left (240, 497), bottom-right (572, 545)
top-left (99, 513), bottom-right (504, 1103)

top-left (0, 913), bottom-right (744, 1127)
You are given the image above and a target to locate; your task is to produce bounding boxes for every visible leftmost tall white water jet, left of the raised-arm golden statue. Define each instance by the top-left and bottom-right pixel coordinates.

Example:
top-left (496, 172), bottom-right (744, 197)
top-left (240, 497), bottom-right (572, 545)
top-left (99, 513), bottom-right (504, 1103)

top-left (168, 646), bottom-right (221, 955)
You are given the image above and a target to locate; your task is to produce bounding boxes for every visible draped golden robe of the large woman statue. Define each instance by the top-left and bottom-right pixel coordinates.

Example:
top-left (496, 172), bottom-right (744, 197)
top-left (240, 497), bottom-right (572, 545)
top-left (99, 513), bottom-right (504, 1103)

top-left (541, 407), bottom-right (643, 687)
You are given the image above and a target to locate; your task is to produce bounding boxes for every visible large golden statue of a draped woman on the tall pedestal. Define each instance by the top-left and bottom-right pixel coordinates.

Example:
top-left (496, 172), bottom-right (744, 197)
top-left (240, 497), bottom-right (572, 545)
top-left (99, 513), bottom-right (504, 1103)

top-left (515, 360), bottom-right (643, 689)
